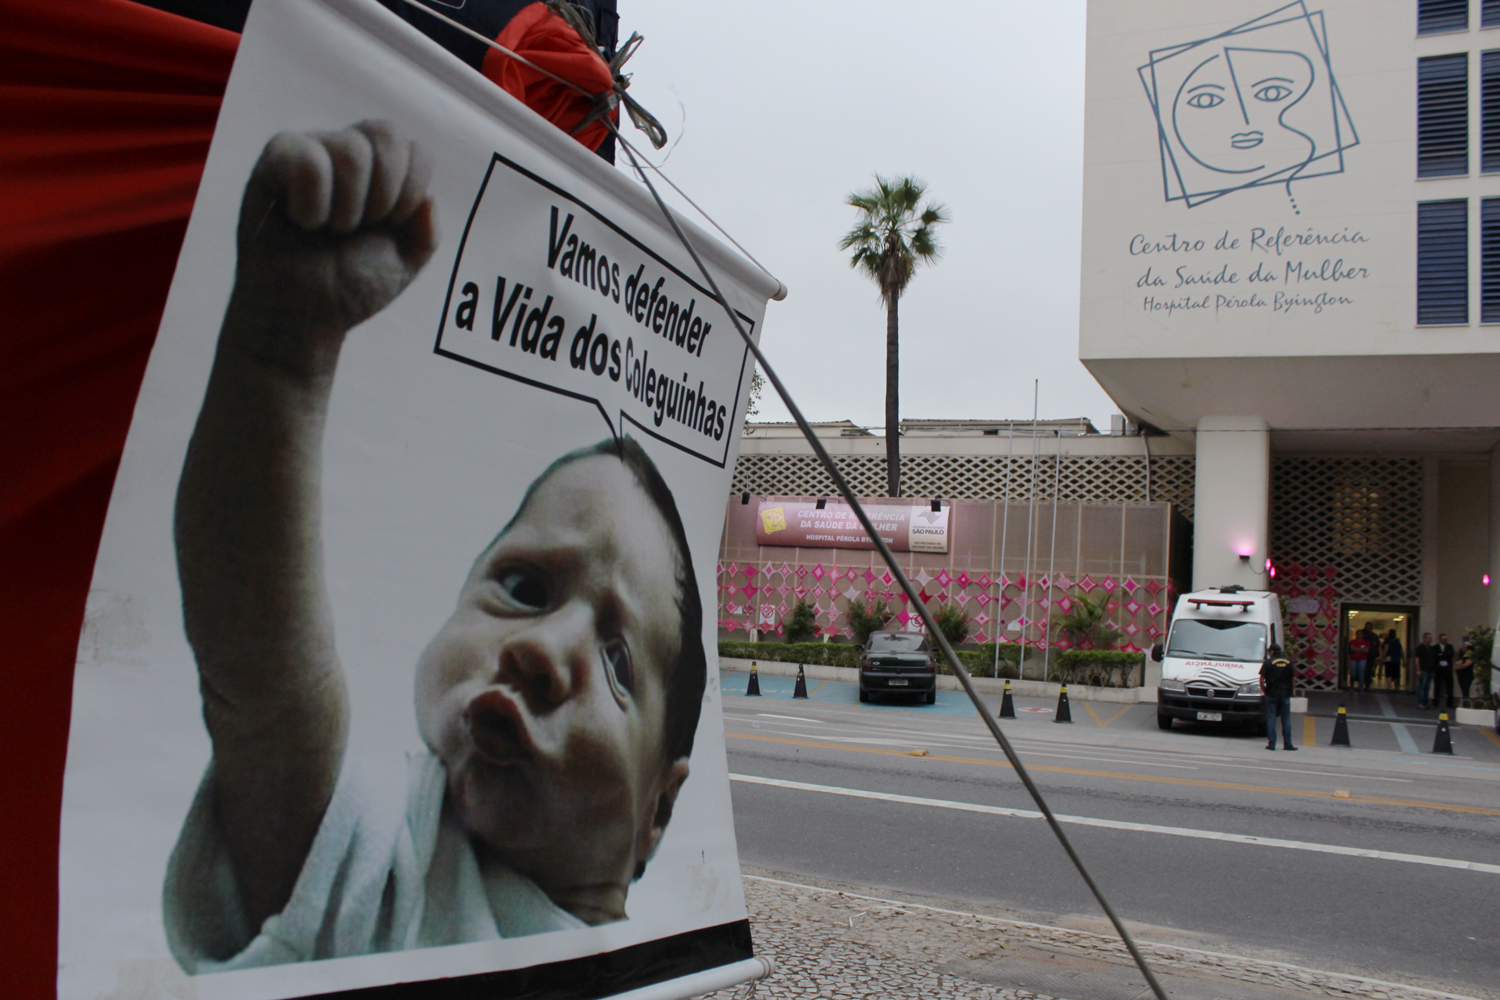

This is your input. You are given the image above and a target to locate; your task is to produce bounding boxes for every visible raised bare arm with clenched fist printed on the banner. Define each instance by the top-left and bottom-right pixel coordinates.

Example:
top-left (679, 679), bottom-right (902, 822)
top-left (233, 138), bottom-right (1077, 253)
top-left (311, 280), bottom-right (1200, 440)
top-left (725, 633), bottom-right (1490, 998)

top-left (176, 121), bottom-right (437, 927)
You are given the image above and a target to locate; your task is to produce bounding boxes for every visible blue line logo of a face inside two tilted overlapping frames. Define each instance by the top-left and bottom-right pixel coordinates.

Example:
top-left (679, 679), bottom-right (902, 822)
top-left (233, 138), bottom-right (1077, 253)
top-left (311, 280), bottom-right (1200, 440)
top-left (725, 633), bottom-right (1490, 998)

top-left (1139, 0), bottom-right (1359, 208)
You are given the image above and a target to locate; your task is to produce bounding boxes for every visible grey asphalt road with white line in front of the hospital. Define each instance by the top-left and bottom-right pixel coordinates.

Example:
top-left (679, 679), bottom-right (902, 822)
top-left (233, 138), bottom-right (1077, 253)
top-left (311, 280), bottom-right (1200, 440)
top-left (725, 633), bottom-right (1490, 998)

top-left (723, 673), bottom-right (1500, 994)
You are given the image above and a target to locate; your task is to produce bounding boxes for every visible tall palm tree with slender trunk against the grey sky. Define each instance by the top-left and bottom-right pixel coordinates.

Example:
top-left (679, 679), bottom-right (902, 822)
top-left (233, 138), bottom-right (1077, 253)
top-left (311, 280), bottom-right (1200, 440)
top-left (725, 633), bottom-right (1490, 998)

top-left (839, 174), bottom-right (948, 496)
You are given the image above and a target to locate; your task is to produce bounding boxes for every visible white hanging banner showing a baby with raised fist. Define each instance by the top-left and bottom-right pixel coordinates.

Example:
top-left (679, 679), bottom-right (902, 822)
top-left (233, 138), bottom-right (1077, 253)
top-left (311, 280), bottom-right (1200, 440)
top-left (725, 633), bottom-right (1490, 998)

top-left (59, 0), bottom-right (777, 1000)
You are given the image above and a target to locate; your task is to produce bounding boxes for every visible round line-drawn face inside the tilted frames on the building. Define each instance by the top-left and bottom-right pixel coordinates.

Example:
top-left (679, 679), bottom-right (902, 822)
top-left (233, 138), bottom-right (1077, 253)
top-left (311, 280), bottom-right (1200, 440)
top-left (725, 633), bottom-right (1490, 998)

top-left (1172, 48), bottom-right (1317, 174)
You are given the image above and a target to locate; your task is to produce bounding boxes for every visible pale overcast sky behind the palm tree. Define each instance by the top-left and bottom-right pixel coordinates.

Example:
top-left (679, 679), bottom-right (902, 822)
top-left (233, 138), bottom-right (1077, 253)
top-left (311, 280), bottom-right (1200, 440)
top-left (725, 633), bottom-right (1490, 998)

top-left (606, 0), bottom-right (1116, 429)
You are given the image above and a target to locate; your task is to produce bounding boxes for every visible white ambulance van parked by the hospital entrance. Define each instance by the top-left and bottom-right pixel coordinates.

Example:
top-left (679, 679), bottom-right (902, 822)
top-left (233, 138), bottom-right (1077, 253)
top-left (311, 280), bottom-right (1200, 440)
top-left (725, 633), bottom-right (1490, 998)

top-left (1151, 586), bottom-right (1286, 733)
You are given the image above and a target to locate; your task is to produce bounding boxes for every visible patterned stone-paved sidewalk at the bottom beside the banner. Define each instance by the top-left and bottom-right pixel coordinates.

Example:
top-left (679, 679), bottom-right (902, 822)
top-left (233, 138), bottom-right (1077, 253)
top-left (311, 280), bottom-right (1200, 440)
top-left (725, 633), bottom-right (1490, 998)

top-left (699, 867), bottom-right (1500, 1000)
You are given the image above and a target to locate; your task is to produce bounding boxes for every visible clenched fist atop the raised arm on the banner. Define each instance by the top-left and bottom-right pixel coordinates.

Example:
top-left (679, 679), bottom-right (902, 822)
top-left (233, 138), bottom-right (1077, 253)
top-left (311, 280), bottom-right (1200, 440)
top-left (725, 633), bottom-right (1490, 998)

top-left (234, 121), bottom-right (438, 337)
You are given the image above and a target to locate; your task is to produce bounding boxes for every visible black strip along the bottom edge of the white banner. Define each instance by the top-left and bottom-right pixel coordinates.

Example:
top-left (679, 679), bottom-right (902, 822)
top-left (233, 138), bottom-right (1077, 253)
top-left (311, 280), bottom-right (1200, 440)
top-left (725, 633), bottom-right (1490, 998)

top-left (283, 921), bottom-right (755, 1000)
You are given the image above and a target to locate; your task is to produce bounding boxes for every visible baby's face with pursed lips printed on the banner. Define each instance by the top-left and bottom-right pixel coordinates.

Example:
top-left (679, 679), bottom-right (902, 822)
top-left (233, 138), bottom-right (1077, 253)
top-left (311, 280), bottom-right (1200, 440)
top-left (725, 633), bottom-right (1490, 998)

top-left (417, 456), bottom-right (687, 904)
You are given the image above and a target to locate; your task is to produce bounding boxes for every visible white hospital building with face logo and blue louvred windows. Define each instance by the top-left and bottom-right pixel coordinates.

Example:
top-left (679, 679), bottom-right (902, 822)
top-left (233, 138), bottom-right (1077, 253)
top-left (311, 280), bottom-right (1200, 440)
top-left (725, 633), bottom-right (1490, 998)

top-left (1079, 0), bottom-right (1500, 690)
